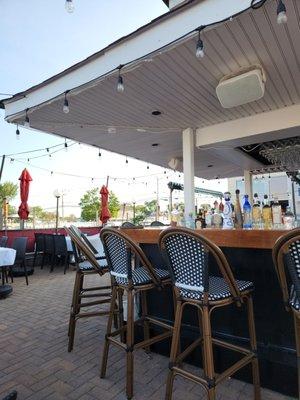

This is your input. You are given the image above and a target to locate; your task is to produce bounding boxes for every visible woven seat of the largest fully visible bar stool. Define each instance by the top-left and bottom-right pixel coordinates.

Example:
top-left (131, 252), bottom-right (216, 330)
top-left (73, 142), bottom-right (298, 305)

top-left (180, 276), bottom-right (254, 301)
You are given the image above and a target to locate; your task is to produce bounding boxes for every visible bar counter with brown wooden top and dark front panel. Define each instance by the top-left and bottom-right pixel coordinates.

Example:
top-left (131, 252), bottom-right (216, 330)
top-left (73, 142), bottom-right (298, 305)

top-left (122, 227), bottom-right (297, 396)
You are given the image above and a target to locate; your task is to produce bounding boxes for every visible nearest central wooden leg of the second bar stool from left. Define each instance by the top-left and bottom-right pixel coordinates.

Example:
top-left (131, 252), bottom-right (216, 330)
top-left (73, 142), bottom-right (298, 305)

top-left (126, 290), bottom-right (134, 399)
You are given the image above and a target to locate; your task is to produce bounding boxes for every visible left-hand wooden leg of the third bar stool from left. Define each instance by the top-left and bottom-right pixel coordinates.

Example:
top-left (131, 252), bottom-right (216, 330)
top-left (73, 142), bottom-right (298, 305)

top-left (165, 301), bottom-right (182, 400)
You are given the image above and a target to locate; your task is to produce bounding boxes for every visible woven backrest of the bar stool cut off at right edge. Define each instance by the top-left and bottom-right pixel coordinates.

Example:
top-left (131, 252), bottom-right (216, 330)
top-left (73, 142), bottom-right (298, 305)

top-left (284, 238), bottom-right (300, 311)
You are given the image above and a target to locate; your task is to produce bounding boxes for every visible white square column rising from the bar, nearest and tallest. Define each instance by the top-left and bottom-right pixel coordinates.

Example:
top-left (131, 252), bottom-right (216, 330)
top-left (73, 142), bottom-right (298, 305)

top-left (182, 128), bottom-right (195, 219)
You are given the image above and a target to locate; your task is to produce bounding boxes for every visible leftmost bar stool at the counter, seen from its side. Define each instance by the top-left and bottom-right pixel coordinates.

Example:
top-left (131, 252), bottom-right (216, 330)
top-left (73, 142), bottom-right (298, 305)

top-left (65, 227), bottom-right (113, 352)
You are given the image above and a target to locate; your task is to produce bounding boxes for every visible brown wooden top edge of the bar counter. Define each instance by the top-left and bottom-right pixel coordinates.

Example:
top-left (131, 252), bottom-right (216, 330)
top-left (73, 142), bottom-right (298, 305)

top-left (122, 228), bottom-right (287, 249)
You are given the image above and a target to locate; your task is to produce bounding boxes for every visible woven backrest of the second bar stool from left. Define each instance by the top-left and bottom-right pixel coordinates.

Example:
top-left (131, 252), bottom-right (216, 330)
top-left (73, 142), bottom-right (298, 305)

top-left (101, 229), bottom-right (132, 279)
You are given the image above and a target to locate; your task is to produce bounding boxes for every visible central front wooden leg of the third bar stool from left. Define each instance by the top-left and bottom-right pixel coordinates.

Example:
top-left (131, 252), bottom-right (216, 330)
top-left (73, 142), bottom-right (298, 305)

top-left (202, 306), bottom-right (216, 400)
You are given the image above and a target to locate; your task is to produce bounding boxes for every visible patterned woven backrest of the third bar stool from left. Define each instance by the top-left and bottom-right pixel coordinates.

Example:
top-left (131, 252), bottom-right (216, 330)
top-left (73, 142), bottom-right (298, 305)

top-left (164, 233), bottom-right (208, 292)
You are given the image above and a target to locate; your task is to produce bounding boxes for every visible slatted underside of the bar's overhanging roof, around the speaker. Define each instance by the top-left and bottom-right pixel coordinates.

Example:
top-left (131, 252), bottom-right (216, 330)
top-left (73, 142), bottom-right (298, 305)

top-left (6, 0), bottom-right (300, 179)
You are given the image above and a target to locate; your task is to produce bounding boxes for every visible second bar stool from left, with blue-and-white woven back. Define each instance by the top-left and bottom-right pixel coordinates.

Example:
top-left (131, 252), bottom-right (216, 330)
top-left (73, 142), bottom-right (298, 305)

top-left (100, 228), bottom-right (172, 399)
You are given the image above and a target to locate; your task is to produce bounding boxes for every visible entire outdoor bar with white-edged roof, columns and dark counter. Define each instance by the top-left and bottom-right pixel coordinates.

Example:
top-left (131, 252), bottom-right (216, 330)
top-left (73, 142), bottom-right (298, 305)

top-left (2, 0), bottom-right (300, 399)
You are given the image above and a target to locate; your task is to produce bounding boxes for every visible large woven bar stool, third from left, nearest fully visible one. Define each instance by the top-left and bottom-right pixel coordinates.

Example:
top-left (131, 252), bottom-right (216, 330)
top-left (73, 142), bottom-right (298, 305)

top-left (159, 228), bottom-right (260, 400)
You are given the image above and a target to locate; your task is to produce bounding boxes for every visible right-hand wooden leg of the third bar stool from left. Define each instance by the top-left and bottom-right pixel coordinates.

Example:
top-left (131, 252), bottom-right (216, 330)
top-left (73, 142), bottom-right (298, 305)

top-left (247, 296), bottom-right (261, 400)
